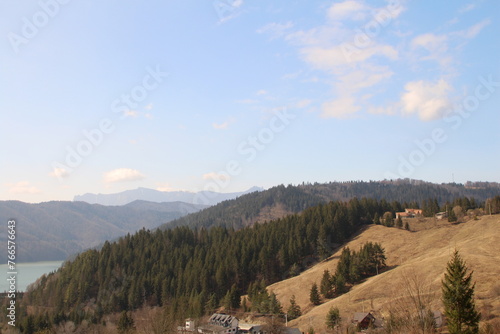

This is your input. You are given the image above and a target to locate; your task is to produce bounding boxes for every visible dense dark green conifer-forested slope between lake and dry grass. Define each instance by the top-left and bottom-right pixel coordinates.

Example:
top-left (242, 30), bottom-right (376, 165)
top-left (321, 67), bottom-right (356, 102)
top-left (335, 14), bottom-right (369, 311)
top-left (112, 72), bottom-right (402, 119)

top-left (18, 199), bottom-right (389, 323)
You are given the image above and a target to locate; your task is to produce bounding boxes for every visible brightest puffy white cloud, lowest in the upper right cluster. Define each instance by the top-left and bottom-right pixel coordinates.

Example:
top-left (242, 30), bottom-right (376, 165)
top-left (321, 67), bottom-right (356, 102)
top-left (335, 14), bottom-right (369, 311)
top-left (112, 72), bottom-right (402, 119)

top-left (401, 79), bottom-right (452, 121)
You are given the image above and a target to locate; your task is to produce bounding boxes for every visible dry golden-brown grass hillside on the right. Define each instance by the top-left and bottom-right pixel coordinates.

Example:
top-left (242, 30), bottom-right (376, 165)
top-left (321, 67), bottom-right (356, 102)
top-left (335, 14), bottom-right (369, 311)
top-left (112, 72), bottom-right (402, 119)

top-left (268, 215), bottom-right (500, 332)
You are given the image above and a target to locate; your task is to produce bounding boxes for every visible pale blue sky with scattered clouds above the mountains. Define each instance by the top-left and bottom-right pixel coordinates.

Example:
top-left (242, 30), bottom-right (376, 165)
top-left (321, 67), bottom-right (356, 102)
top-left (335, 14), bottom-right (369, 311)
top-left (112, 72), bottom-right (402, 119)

top-left (0, 0), bottom-right (500, 203)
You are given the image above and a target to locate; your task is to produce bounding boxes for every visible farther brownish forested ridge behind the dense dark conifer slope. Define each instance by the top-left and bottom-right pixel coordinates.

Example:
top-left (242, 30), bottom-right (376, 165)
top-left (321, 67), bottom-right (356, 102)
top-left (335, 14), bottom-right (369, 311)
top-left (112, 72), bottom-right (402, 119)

top-left (162, 180), bottom-right (500, 229)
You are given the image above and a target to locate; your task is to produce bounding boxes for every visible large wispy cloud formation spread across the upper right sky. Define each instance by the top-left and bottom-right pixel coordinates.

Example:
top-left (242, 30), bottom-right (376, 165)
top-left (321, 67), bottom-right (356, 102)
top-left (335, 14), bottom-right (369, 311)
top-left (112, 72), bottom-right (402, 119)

top-left (270, 0), bottom-right (491, 121)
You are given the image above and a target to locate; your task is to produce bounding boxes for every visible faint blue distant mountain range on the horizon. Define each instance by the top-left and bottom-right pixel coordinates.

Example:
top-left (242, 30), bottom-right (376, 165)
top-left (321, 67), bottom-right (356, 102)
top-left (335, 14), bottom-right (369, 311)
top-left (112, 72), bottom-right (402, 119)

top-left (73, 187), bottom-right (264, 206)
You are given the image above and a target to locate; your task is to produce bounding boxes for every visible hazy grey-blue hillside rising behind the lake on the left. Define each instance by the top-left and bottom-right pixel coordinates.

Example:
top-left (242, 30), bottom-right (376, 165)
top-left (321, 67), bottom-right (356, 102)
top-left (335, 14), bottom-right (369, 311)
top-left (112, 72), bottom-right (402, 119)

top-left (0, 201), bottom-right (206, 263)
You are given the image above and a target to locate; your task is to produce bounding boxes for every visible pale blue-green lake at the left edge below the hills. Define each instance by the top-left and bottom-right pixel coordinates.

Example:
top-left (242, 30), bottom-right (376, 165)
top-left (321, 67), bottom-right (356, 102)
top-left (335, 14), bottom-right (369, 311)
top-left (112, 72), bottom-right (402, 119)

top-left (0, 261), bottom-right (63, 292)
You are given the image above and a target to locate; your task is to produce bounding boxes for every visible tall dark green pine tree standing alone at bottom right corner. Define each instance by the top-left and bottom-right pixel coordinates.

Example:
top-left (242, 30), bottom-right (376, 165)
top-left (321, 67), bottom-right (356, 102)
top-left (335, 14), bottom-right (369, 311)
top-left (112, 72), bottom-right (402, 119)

top-left (442, 250), bottom-right (481, 334)
